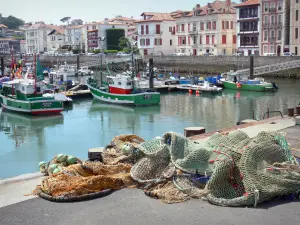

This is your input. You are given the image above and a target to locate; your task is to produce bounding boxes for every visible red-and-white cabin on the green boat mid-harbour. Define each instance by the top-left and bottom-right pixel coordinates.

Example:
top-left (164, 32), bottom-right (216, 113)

top-left (107, 74), bottom-right (133, 94)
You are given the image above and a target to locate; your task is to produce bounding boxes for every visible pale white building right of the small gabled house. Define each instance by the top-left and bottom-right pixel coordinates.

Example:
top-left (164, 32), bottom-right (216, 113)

top-left (64, 25), bottom-right (87, 49)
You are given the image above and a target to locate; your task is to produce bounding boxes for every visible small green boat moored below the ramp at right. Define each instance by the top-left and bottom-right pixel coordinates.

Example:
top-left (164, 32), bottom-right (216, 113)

top-left (221, 73), bottom-right (278, 92)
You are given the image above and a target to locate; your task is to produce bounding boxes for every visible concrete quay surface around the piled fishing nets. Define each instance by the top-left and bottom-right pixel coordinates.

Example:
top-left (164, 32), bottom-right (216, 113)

top-left (0, 117), bottom-right (300, 225)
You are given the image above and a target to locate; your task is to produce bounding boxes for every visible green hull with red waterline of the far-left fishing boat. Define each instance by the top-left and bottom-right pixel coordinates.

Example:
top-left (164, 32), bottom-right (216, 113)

top-left (0, 95), bottom-right (63, 115)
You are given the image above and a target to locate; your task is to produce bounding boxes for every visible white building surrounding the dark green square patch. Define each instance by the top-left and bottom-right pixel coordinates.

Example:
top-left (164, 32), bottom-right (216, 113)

top-left (84, 18), bottom-right (128, 52)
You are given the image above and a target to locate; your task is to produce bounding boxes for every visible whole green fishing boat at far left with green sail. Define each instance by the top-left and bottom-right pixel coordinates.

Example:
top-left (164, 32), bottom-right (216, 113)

top-left (0, 56), bottom-right (63, 115)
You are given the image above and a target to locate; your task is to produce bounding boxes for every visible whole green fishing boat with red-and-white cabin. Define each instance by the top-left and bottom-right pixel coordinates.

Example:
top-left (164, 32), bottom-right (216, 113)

top-left (87, 74), bottom-right (160, 106)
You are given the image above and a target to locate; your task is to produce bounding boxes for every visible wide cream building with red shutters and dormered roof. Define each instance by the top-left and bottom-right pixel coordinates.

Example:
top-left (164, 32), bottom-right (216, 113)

top-left (174, 0), bottom-right (237, 55)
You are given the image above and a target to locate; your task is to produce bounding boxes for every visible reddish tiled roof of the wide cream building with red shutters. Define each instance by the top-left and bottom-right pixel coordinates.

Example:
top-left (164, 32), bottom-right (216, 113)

top-left (173, 0), bottom-right (236, 18)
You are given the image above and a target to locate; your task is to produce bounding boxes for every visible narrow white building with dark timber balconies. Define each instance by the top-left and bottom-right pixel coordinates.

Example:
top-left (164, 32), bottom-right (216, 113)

top-left (234, 0), bottom-right (261, 56)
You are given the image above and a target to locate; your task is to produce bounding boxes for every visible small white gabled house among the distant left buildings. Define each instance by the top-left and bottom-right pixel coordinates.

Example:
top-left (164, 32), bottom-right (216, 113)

top-left (47, 27), bottom-right (65, 51)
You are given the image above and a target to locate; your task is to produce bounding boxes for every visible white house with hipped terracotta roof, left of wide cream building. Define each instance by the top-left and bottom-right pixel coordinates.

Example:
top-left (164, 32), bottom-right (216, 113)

top-left (136, 12), bottom-right (175, 56)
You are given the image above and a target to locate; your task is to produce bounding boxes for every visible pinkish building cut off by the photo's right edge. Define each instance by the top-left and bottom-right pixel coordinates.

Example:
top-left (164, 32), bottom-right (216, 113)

top-left (286, 0), bottom-right (300, 55)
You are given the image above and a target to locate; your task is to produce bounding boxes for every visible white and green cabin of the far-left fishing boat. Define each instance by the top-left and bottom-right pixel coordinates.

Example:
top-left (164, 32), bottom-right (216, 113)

top-left (2, 79), bottom-right (43, 100)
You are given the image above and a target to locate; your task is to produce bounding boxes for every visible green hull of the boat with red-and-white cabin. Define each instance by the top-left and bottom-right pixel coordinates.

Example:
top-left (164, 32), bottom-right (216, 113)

top-left (88, 85), bottom-right (160, 106)
